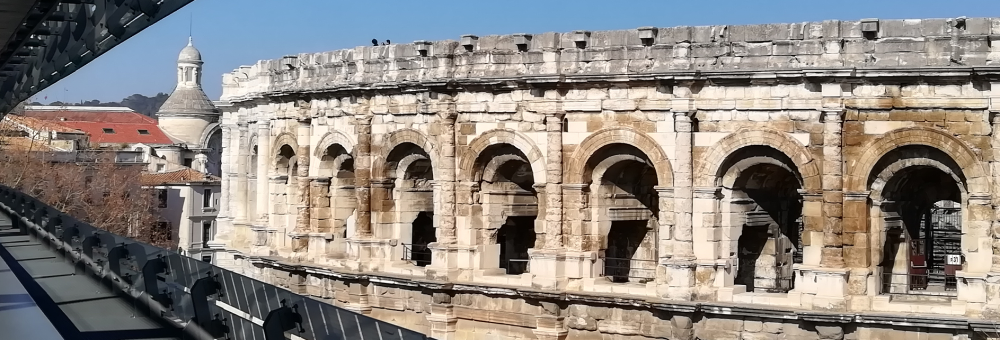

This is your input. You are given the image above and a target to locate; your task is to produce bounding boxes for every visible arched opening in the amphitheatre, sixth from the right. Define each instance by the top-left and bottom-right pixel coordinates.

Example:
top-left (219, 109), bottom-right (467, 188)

top-left (313, 144), bottom-right (358, 257)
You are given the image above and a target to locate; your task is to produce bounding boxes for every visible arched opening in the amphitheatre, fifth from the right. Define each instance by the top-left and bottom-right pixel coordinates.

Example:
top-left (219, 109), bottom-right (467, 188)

top-left (372, 142), bottom-right (437, 266)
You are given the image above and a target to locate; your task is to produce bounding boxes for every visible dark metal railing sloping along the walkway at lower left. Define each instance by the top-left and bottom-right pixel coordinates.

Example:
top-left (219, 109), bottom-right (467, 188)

top-left (0, 185), bottom-right (429, 340)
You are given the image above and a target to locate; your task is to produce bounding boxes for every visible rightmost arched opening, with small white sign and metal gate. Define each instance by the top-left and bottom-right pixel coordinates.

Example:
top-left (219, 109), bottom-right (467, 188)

top-left (869, 146), bottom-right (965, 295)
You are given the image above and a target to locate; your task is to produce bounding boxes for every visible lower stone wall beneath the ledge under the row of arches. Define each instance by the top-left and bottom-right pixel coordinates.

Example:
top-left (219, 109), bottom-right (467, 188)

top-left (232, 259), bottom-right (976, 340)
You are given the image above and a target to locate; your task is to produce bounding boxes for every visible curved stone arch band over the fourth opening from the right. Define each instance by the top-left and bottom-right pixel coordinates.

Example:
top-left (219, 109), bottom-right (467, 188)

top-left (458, 129), bottom-right (546, 183)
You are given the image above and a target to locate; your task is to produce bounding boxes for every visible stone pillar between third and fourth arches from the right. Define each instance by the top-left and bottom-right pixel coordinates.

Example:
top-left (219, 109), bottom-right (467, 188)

top-left (545, 113), bottom-right (565, 249)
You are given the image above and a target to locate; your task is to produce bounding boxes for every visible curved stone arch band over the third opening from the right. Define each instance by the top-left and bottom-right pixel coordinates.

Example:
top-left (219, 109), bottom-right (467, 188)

top-left (566, 127), bottom-right (674, 187)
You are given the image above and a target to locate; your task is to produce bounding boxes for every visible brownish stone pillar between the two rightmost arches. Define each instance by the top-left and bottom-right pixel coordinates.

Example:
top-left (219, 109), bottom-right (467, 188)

top-left (820, 108), bottom-right (844, 268)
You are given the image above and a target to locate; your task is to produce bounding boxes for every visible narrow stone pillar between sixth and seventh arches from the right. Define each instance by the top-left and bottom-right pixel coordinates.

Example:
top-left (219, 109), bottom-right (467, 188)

top-left (292, 118), bottom-right (312, 253)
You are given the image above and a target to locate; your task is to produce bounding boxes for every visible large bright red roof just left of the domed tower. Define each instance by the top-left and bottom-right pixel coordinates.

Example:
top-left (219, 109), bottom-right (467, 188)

top-left (24, 107), bottom-right (174, 144)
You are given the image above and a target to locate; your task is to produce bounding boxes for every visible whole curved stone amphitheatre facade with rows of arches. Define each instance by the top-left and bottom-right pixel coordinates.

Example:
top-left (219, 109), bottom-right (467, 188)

top-left (216, 18), bottom-right (1000, 339)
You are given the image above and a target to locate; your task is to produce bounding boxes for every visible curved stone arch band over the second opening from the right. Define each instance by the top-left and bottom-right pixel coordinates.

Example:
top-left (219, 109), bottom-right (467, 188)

top-left (694, 129), bottom-right (822, 192)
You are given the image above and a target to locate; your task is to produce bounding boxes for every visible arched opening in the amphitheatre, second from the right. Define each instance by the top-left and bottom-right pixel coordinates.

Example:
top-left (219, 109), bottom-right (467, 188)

top-left (717, 146), bottom-right (803, 292)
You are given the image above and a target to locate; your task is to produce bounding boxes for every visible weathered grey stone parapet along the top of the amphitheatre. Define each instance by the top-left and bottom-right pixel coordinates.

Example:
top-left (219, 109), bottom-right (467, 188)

top-left (222, 18), bottom-right (1000, 101)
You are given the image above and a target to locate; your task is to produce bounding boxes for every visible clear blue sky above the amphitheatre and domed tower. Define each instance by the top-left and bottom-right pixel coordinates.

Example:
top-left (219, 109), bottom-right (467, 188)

top-left (34, 0), bottom-right (1000, 103)
